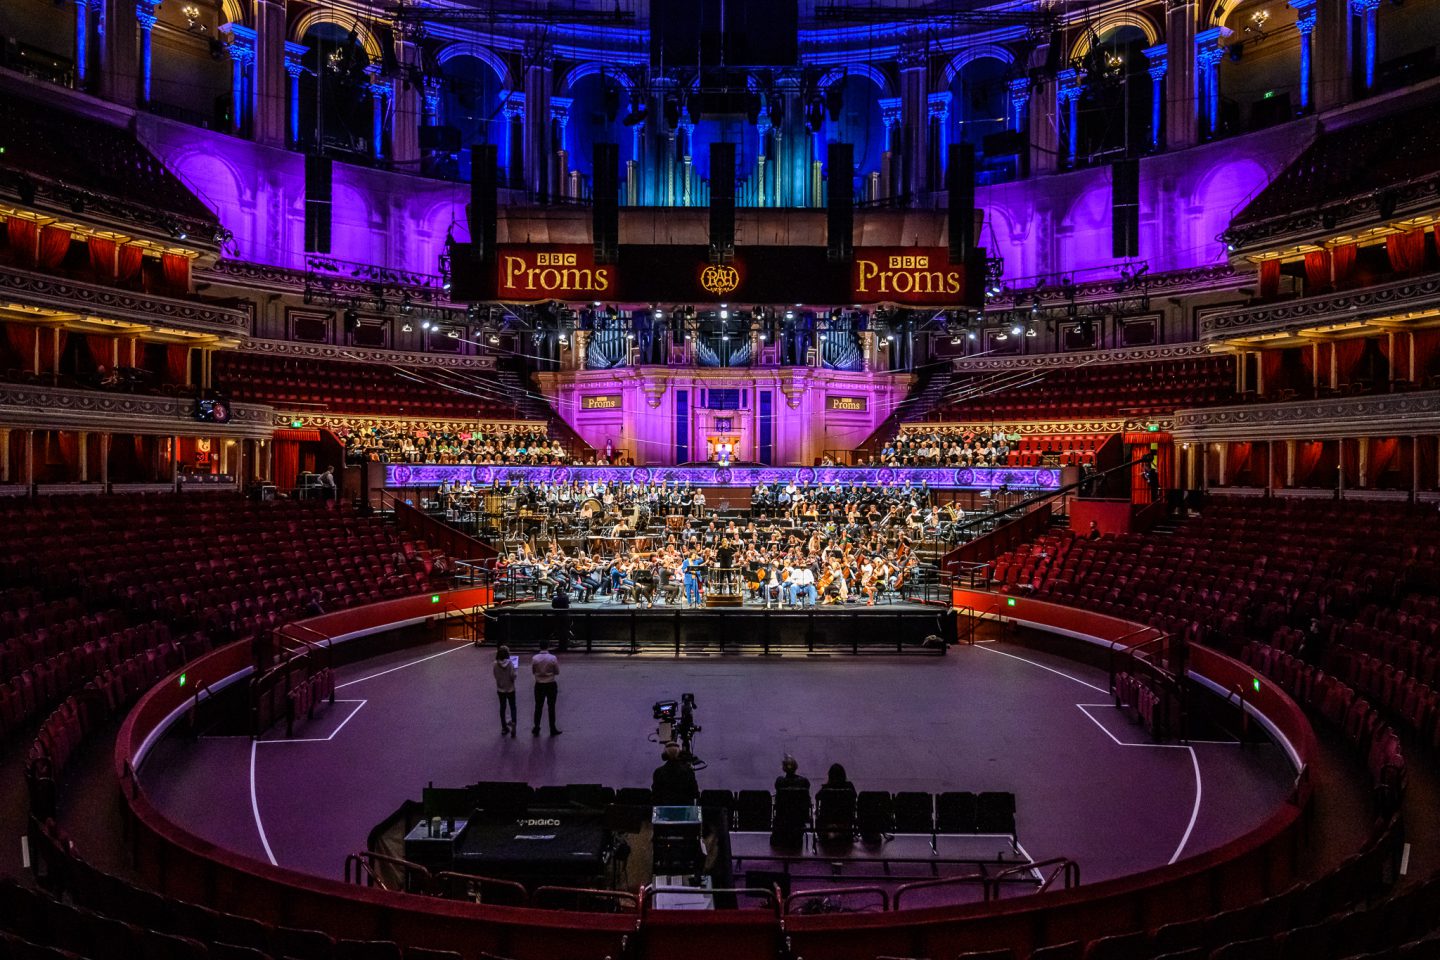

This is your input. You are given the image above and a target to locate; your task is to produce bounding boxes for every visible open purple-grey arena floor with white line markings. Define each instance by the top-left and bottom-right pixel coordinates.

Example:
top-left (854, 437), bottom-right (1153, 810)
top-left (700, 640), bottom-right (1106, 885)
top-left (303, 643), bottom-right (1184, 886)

top-left (141, 640), bottom-right (1293, 884)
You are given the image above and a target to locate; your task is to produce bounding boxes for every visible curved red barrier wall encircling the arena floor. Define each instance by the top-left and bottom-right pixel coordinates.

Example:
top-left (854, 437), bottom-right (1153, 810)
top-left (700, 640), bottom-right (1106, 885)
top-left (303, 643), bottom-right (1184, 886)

top-left (115, 590), bottom-right (1316, 960)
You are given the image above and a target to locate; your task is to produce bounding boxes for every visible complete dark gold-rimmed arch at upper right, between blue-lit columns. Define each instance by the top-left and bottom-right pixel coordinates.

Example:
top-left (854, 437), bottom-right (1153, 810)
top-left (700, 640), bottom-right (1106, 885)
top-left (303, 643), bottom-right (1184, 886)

top-left (1077, 26), bottom-right (1153, 163)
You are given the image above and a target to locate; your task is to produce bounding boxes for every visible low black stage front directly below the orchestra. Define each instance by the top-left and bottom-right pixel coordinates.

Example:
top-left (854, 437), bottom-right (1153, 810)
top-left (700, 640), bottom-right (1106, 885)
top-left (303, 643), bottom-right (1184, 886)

top-left (485, 604), bottom-right (955, 656)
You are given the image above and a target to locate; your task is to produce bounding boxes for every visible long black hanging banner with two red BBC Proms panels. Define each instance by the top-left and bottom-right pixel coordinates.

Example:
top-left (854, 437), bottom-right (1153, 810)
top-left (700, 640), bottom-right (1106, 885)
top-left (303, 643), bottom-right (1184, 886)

top-left (451, 243), bottom-right (984, 308)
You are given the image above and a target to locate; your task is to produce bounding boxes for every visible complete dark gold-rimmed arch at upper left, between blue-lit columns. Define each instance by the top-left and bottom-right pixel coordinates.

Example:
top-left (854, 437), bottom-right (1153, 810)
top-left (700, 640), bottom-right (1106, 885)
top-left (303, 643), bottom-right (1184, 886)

top-left (300, 23), bottom-right (374, 157)
